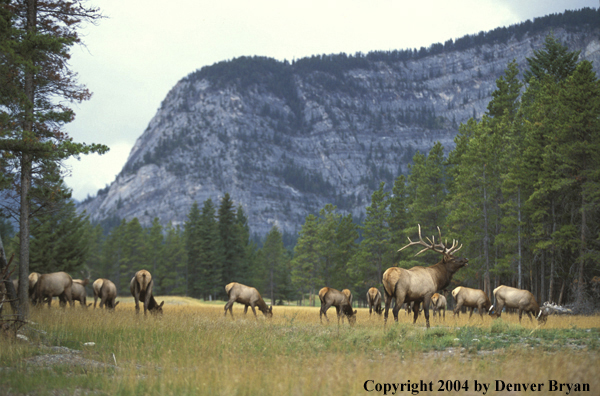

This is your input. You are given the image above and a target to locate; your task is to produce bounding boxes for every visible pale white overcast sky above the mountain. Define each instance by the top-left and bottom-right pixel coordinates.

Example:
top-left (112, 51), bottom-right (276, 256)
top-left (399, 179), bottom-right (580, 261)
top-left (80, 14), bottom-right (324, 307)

top-left (65, 0), bottom-right (599, 200)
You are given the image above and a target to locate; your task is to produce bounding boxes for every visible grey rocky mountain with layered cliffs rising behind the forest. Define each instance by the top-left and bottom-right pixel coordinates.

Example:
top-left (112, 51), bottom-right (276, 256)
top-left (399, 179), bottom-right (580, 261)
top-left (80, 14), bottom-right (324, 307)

top-left (78, 9), bottom-right (600, 234)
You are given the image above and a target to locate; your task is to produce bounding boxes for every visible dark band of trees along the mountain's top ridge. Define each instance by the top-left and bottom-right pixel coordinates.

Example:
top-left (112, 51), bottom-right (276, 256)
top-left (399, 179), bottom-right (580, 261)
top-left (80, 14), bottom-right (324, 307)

top-left (186, 8), bottom-right (600, 93)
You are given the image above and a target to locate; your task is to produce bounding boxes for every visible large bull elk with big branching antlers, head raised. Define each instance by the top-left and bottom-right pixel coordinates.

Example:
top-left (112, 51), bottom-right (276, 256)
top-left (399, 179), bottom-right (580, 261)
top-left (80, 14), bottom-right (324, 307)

top-left (383, 225), bottom-right (469, 328)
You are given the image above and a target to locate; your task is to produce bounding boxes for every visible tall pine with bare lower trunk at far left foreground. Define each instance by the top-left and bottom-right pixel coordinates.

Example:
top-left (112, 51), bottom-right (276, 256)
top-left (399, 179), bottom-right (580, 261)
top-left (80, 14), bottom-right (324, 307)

top-left (0, 0), bottom-right (108, 319)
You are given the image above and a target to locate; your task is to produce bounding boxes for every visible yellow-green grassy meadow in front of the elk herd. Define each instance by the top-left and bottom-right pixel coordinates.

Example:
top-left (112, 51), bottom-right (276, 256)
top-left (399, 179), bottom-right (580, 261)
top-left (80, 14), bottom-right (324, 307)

top-left (0, 297), bottom-right (600, 395)
